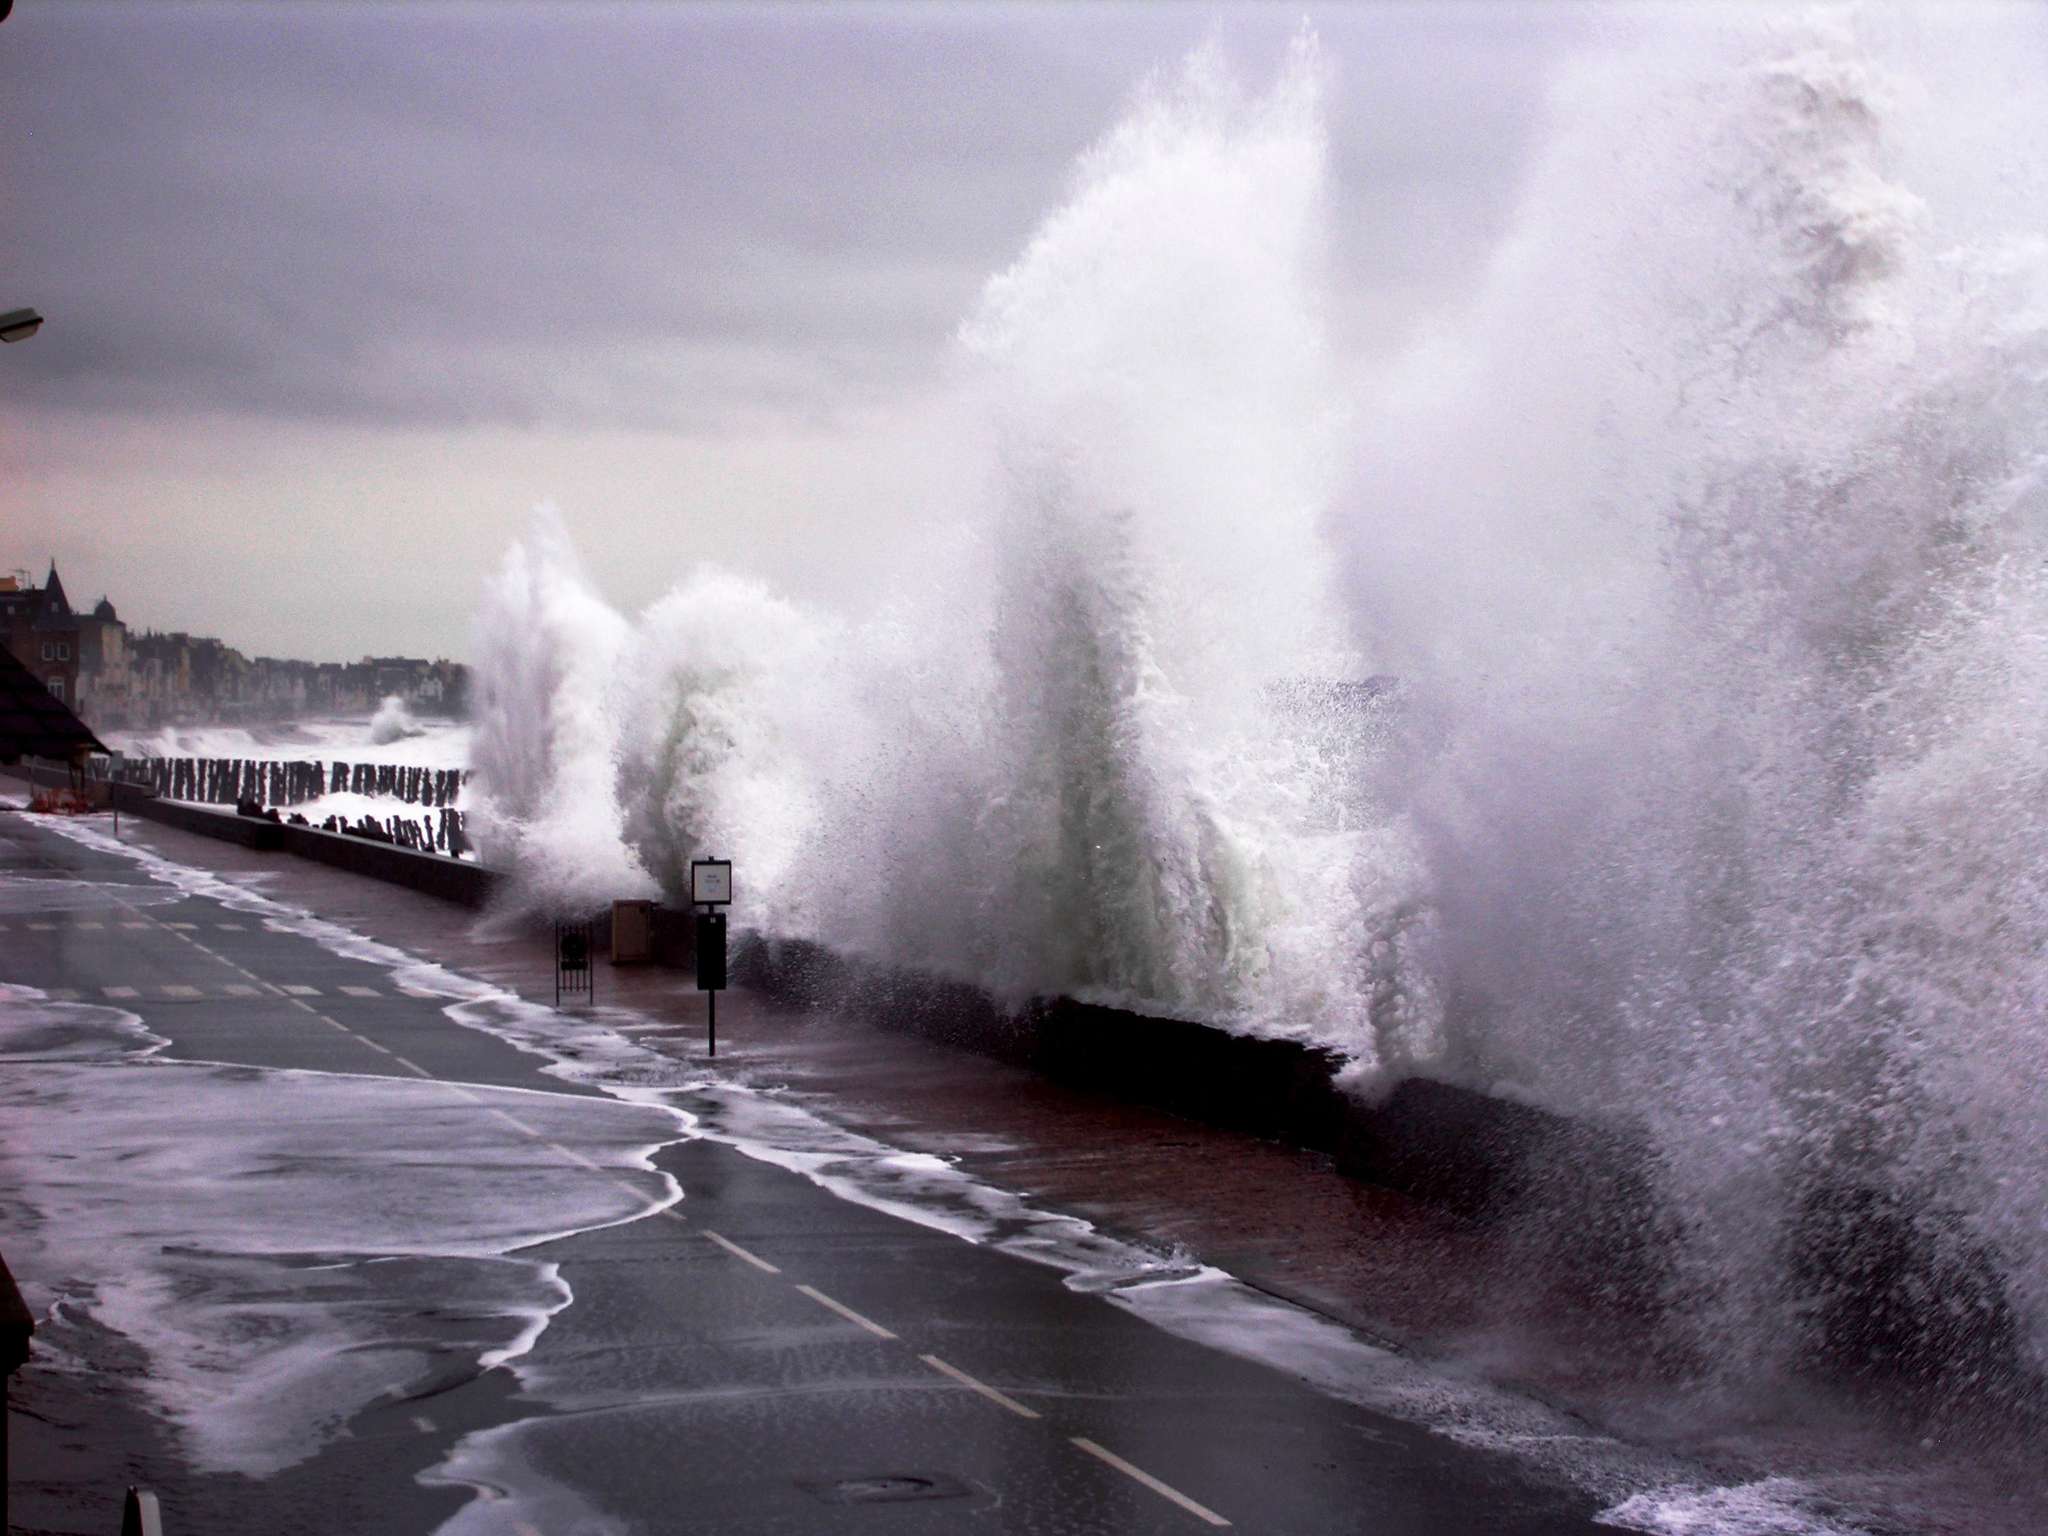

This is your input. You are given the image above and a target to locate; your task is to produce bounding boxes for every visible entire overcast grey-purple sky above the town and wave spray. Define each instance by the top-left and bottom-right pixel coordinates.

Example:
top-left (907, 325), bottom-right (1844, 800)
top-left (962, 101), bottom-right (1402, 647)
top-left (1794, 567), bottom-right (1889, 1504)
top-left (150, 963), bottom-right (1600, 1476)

top-left (0, 0), bottom-right (1589, 659)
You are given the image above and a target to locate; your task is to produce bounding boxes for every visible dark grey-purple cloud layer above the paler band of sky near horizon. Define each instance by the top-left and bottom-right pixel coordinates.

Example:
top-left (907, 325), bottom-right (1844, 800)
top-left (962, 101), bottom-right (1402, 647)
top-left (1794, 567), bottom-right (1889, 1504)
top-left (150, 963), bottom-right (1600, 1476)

top-left (0, 0), bottom-right (1559, 426)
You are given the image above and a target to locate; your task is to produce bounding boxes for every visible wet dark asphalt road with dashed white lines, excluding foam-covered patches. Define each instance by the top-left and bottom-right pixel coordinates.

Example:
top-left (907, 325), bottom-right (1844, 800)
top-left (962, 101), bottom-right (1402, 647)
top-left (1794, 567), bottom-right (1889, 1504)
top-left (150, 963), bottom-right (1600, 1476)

top-left (0, 811), bottom-right (1608, 1536)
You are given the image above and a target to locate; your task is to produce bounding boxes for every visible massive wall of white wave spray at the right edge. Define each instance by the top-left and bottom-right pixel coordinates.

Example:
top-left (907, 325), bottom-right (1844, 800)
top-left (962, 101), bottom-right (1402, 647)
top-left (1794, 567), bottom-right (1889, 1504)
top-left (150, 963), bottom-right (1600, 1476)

top-left (1346, 18), bottom-right (2048, 1400)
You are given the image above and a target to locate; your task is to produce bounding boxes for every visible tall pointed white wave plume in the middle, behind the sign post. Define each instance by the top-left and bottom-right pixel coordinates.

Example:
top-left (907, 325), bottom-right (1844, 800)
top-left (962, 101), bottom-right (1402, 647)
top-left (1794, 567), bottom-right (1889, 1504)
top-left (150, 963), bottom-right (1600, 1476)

top-left (823, 39), bottom-right (1433, 1057)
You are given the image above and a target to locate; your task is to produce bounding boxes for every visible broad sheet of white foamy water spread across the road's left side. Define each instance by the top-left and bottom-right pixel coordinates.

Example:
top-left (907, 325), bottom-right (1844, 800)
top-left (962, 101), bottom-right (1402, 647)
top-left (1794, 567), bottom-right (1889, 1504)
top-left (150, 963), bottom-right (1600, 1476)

top-left (0, 985), bottom-right (686, 1477)
